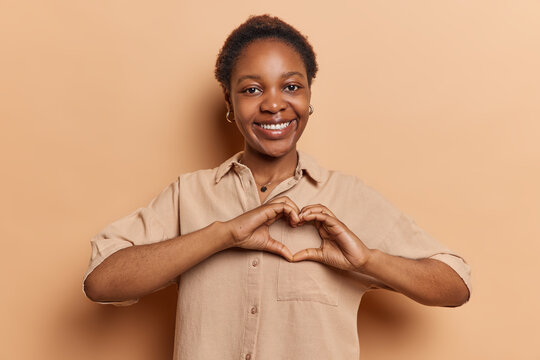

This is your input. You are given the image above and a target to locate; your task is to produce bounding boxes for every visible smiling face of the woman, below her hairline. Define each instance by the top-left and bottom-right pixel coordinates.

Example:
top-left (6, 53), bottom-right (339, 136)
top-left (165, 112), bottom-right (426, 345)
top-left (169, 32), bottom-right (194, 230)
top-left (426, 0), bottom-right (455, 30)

top-left (226, 39), bottom-right (311, 174)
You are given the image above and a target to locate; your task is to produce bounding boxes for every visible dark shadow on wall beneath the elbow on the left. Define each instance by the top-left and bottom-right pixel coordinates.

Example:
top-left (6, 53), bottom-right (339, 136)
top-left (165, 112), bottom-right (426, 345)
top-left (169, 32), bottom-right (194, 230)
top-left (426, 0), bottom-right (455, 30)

top-left (58, 286), bottom-right (177, 360)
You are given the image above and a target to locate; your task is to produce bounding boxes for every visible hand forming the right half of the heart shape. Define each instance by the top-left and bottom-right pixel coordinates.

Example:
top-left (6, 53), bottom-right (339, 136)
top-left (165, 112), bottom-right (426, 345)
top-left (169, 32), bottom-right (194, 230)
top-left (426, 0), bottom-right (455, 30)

top-left (293, 204), bottom-right (371, 271)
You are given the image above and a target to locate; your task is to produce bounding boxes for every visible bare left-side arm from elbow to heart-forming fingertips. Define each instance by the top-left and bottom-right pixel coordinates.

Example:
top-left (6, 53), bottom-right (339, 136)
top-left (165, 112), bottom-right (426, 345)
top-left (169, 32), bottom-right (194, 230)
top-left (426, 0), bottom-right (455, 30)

top-left (84, 198), bottom-right (298, 302)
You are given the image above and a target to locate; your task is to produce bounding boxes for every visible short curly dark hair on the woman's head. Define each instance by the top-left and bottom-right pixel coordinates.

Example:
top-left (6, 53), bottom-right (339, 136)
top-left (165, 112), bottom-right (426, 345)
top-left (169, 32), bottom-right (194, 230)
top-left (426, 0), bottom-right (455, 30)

top-left (215, 15), bottom-right (318, 91)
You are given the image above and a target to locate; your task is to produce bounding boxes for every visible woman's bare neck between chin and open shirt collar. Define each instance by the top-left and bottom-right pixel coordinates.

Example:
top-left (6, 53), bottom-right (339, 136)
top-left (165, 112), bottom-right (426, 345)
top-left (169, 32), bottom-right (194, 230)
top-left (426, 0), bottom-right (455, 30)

top-left (242, 148), bottom-right (298, 185)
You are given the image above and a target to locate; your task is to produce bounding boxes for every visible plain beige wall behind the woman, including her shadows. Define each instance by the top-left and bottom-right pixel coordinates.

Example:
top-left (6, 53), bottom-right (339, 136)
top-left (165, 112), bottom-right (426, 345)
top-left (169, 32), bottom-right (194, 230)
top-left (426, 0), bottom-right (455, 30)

top-left (0, 0), bottom-right (540, 360)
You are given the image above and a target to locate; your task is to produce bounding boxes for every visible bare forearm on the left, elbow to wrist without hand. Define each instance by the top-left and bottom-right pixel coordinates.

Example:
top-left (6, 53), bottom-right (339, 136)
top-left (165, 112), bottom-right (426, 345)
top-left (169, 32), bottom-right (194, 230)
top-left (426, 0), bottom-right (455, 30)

top-left (84, 222), bottom-right (229, 302)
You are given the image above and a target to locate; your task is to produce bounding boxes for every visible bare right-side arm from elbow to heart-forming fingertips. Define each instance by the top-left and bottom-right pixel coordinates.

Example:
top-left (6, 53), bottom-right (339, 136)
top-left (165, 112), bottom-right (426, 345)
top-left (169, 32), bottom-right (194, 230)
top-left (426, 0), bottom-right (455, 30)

top-left (293, 205), bottom-right (469, 306)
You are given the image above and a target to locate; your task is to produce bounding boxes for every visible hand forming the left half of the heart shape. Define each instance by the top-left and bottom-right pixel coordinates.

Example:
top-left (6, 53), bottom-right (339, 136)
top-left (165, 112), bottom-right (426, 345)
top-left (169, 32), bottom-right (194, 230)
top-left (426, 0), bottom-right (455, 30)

top-left (225, 196), bottom-right (300, 261)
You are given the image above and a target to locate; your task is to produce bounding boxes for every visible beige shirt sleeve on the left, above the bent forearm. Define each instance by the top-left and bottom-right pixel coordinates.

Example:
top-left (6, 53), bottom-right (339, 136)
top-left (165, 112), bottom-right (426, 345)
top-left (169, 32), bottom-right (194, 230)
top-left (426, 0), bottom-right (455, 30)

top-left (83, 178), bottom-right (180, 306)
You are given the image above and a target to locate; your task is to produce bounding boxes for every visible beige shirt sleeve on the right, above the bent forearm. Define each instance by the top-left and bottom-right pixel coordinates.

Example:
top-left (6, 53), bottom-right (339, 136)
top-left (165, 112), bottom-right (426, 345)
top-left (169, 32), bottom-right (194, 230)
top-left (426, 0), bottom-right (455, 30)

top-left (378, 214), bottom-right (472, 293)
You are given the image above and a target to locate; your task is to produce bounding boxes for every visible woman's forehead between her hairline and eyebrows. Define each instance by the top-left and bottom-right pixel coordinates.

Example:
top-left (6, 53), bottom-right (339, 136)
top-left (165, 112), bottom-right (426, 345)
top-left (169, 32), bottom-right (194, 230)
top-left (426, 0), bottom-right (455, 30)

top-left (231, 39), bottom-right (307, 79)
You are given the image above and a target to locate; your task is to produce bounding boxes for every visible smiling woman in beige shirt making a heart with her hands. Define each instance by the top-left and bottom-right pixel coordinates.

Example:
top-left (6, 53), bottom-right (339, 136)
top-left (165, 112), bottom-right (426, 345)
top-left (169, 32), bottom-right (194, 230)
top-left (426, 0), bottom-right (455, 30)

top-left (84, 16), bottom-right (469, 360)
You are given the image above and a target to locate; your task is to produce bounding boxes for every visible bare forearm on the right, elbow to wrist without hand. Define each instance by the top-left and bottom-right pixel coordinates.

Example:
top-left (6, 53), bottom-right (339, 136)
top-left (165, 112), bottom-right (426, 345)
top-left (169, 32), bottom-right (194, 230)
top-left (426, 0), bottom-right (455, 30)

top-left (360, 250), bottom-right (469, 306)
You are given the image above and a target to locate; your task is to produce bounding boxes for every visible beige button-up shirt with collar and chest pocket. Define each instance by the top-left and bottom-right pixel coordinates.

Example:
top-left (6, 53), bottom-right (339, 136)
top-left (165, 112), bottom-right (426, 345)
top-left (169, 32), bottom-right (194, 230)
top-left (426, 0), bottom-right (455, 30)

top-left (85, 151), bottom-right (470, 360)
